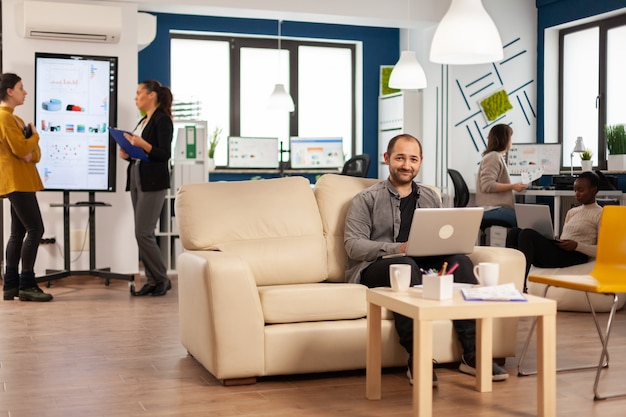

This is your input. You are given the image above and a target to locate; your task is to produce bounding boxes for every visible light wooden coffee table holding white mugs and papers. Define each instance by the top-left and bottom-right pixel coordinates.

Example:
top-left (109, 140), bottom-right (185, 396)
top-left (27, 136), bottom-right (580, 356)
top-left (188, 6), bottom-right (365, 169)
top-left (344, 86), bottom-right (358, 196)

top-left (365, 288), bottom-right (556, 417)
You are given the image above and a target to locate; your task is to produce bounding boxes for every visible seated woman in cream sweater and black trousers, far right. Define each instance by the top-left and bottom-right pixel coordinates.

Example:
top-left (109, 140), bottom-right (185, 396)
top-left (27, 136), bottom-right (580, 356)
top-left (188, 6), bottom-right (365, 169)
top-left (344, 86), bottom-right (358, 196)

top-left (506, 171), bottom-right (602, 292)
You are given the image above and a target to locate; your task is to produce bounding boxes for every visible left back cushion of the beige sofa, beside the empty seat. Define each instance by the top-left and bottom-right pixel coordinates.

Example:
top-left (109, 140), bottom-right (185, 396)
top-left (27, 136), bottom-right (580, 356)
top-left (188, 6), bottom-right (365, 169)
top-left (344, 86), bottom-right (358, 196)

top-left (175, 177), bottom-right (328, 285)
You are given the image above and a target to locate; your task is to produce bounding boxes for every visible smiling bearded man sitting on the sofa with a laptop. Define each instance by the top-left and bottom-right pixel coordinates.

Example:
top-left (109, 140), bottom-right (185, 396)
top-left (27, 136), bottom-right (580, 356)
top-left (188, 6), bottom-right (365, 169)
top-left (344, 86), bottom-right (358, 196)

top-left (344, 134), bottom-right (509, 387)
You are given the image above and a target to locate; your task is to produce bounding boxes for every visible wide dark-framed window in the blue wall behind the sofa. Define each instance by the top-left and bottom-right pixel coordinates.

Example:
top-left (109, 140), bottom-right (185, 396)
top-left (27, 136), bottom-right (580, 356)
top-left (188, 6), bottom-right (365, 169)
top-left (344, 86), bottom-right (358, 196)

top-left (171, 33), bottom-right (356, 166)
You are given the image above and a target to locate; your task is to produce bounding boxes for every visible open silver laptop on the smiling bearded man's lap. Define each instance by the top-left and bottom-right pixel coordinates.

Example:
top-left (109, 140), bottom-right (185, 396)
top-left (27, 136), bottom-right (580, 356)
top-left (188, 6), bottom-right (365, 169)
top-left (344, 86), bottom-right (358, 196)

top-left (406, 207), bottom-right (484, 256)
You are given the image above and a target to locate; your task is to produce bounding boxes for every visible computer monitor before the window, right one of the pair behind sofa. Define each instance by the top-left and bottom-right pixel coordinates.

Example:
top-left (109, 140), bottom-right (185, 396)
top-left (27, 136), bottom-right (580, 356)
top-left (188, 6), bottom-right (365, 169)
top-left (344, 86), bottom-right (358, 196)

top-left (289, 137), bottom-right (344, 169)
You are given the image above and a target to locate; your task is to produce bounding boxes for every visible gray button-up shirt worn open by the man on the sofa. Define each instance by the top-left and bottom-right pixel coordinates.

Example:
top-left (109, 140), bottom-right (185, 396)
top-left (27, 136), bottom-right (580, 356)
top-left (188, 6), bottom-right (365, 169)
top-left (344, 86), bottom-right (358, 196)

top-left (343, 179), bottom-right (441, 283)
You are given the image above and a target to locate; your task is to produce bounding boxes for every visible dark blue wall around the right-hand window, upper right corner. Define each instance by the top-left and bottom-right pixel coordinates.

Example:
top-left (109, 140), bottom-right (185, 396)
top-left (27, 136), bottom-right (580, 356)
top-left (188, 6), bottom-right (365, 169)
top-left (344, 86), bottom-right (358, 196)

top-left (535, 0), bottom-right (626, 142)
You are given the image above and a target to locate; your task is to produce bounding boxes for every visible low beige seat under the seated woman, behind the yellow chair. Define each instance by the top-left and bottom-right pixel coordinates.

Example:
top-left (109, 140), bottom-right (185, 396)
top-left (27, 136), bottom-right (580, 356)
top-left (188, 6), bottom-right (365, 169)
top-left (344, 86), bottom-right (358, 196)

top-left (528, 261), bottom-right (626, 313)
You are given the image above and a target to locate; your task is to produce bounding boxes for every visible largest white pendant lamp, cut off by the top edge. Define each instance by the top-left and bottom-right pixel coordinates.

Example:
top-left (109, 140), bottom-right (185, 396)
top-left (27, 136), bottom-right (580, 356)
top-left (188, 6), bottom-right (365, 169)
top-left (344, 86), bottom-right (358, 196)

top-left (430, 0), bottom-right (504, 65)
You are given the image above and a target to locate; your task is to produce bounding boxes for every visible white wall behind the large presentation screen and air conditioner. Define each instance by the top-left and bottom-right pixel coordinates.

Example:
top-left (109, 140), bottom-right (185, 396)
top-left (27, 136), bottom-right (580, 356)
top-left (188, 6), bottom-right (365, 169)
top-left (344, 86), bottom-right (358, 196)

top-left (2, 0), bottom-right (138, 275)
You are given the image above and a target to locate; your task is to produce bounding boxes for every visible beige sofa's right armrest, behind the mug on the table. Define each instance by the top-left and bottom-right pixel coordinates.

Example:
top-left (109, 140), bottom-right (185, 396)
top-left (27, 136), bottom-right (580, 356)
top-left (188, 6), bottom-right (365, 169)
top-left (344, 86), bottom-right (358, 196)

top-left (469, 246), bottom-right (526, 291)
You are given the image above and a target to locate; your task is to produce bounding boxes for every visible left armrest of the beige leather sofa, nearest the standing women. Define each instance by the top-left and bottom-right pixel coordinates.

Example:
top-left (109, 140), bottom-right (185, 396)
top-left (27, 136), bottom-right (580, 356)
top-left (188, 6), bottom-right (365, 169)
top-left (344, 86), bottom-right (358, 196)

top-left (177, 251), bottom-right (265, 379)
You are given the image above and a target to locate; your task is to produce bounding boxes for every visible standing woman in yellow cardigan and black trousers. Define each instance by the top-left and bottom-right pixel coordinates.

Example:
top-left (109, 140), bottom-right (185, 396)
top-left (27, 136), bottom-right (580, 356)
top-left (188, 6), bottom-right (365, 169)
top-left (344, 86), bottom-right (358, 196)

top-left (0, 73), bottom-right (52, 301)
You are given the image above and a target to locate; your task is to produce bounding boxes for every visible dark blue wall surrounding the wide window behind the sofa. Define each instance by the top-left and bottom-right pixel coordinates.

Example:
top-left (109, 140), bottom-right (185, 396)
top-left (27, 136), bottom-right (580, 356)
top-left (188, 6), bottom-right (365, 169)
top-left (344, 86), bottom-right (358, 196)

top-left (138, 14), bottom-right (400, 177)
